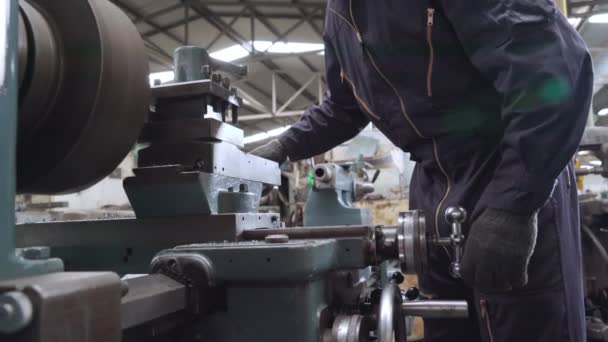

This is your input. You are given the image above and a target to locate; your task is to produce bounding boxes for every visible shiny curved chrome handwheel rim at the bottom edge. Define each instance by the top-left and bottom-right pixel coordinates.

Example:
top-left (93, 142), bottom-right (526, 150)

top-left (376, 282), bottom-right (407, 342)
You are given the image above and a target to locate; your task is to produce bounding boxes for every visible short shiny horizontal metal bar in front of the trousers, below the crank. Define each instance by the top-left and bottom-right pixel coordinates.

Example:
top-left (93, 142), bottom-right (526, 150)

top-left (401, 300), bottom-right (469, 319)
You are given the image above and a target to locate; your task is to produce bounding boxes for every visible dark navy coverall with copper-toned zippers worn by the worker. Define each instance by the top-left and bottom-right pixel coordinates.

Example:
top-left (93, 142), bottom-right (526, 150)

top-left (279, 0), bottom-right (593, 342)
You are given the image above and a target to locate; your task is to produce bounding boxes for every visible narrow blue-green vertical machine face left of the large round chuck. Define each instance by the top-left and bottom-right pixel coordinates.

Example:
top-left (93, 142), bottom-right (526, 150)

top-left (0, 0), bottom-right (18, 279)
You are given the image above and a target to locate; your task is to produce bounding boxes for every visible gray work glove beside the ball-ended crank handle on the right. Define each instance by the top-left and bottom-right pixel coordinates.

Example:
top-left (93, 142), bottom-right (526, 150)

top-left (461, 209), bottom-right (538, 292)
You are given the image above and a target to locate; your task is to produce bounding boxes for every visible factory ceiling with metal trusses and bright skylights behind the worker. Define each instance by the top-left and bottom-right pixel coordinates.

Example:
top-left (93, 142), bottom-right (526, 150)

top-left (111, 0), bottom-right (608, 140)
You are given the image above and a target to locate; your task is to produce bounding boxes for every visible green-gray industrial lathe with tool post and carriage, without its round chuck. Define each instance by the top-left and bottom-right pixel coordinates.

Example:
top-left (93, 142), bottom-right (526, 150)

top-left (0, 0), bottom-right (468, 342)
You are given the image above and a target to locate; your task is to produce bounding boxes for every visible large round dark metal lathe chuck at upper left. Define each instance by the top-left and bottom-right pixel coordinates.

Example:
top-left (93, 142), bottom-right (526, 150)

top-left (17, 0), bottom-right (149, 193)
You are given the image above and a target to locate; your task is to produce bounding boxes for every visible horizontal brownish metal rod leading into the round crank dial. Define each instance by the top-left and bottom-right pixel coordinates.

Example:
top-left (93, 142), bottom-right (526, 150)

top-left (242, 226), bottom-right (382, 240)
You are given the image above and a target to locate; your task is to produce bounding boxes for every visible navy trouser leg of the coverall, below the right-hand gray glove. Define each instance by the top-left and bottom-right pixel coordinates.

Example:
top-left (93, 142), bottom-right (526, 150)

top-left (421, 168), bottom-right (585, 342)
